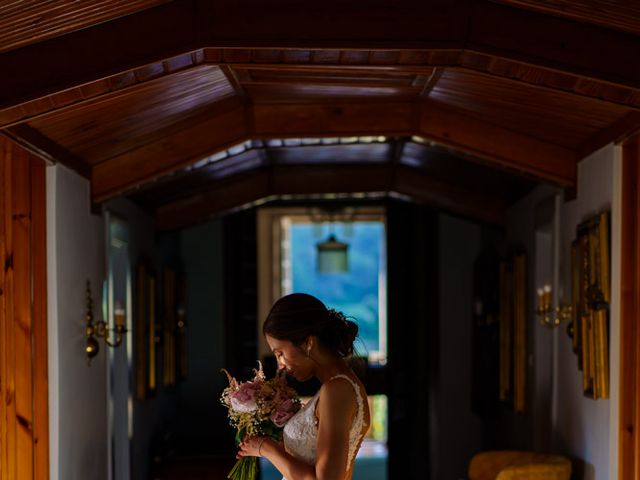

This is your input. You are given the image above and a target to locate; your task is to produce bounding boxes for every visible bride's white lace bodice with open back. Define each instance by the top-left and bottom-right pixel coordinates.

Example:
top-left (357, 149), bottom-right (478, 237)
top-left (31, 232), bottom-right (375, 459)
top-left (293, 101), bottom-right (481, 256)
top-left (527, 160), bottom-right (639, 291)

top-left (283, 375), bottom-right (364, 480)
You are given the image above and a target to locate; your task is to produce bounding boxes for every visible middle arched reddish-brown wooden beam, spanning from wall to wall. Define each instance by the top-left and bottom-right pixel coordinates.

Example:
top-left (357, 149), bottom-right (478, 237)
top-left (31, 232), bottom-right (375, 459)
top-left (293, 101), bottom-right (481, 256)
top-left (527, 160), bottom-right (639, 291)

top-left (91, 102), bottom-right (577, 202)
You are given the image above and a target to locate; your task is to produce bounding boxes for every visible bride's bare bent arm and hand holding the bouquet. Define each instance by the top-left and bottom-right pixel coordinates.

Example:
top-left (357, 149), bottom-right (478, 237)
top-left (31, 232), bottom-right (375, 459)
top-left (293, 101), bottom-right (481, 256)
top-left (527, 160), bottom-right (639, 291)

top-left (238, 379), bottom-right (356, 480)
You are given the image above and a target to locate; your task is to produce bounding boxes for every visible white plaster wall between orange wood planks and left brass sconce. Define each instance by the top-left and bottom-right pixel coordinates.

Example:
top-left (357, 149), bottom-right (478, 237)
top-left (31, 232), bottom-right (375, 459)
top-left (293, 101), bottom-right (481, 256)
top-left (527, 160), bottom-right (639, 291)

top-left (47, 165), bottom-right (107, 480)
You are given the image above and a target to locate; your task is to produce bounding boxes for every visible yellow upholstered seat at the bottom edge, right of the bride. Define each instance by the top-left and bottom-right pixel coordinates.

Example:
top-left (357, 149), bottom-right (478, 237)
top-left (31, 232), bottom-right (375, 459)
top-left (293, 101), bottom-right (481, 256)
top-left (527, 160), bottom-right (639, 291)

top-left (469, 450), bottom-right (571, 480)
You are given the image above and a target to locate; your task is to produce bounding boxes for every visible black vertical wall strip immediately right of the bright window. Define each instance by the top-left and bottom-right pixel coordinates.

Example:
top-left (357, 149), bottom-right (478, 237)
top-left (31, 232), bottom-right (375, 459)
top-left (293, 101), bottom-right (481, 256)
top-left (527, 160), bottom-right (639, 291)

top-left (387, 200), bottom-right (438, 479)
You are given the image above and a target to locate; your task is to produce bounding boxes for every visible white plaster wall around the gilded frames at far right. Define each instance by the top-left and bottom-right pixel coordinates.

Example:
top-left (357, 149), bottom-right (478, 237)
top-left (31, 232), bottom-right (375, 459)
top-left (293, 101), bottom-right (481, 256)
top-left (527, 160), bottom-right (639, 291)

top-left (553, 145), bottom-right (620, 480)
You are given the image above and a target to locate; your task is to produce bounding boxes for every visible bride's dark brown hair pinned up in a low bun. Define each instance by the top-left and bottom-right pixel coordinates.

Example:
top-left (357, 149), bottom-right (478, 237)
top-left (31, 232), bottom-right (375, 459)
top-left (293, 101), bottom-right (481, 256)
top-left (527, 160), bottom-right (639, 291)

top-left (262, 293), bottom-right (358, 357)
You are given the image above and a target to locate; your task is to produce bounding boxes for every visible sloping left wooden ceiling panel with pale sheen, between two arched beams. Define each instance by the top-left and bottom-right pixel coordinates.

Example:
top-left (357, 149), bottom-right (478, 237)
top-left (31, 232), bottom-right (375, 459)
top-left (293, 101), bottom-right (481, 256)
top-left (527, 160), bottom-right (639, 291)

top-left (30, 65), bottom-right (234, 164)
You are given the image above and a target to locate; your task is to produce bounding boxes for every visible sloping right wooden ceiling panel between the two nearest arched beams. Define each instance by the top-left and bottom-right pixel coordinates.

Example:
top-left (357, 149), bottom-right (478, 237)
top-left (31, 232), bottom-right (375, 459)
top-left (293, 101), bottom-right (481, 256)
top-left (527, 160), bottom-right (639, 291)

top-left (429, 68), bottom-right (630, 149)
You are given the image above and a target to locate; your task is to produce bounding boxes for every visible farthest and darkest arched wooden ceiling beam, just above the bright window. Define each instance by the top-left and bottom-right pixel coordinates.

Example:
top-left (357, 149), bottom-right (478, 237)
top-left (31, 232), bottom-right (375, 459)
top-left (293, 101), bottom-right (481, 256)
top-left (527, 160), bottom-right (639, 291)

top-left (156, 164), bottom-right (506, 230)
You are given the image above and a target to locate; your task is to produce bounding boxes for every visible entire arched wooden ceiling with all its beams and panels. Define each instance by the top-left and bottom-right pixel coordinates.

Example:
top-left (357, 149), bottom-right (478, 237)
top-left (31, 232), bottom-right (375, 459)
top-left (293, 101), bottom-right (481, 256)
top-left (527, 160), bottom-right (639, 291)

top-left (0, 0), bottom-right (640, 228)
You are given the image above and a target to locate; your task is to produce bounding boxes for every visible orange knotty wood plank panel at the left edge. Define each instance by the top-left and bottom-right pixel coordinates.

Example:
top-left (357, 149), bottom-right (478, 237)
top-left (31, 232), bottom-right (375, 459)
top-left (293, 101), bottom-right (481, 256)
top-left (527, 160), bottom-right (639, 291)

top-left (0, 136), bottom-right (49, 480)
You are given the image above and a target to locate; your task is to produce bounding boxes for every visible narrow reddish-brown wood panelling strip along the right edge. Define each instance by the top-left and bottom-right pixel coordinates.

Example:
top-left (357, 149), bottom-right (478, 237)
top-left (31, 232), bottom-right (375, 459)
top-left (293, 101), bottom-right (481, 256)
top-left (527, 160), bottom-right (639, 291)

top-left (618, 135), bottom-right (640, 480)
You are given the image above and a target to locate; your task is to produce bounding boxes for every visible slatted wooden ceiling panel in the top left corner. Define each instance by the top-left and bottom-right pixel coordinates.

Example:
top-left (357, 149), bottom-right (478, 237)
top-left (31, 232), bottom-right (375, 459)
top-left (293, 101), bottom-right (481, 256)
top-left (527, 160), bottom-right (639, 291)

top-left (0, 0), bottom-right (169, 52)
